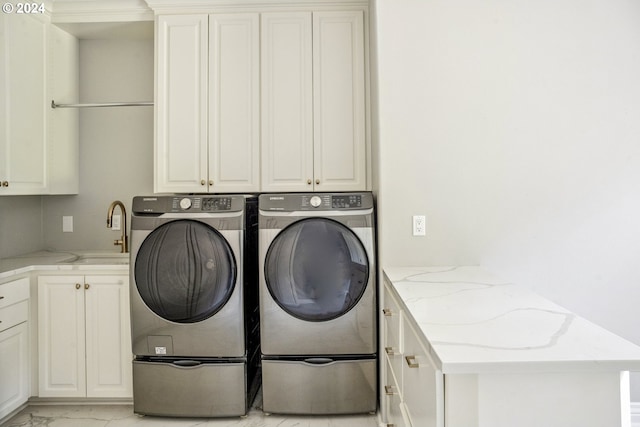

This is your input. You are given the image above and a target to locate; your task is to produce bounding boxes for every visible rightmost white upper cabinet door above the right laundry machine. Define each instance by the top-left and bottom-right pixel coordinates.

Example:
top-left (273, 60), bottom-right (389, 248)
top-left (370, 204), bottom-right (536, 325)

top-left (313, 11), bottom-right (366, 191)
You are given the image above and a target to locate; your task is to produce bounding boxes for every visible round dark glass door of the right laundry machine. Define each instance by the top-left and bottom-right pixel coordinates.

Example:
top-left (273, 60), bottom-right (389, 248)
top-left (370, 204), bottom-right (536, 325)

top-left (264, 218), bottom-right (369, 322)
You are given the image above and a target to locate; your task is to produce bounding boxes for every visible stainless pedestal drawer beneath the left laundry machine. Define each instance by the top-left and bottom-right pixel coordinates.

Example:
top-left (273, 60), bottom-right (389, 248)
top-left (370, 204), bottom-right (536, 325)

top-left (133, 360), bottom-right (248, 417)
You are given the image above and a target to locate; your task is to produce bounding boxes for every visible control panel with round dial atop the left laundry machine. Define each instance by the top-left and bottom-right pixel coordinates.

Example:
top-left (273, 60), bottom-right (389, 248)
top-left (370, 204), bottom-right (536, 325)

top-left (133, 195), bottom-right (245, 214)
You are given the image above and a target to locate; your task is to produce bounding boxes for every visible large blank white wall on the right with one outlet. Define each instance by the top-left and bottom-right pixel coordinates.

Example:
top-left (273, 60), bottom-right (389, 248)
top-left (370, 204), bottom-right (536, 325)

top-left (375, 0), bottom-right (640, 401)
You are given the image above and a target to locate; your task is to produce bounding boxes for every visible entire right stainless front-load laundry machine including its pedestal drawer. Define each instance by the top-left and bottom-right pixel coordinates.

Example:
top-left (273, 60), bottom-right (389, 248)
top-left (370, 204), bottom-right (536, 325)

top-left (259, 193), bottom-right (377, 414)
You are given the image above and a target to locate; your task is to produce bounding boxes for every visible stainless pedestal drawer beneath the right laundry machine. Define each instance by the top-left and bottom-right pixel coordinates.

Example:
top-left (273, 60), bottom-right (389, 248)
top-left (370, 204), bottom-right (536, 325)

top-left (262, 359), bottom-right (377, 414)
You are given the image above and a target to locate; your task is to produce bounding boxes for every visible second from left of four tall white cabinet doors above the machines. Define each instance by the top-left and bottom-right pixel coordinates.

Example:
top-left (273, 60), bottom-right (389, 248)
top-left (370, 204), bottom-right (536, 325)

top-left (209, 14), bottom-right (260, 192)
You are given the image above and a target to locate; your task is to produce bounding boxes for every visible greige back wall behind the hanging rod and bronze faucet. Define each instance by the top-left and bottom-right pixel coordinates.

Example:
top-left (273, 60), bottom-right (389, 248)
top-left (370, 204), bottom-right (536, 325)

top-left (43, 39), bottom-right (153, 252)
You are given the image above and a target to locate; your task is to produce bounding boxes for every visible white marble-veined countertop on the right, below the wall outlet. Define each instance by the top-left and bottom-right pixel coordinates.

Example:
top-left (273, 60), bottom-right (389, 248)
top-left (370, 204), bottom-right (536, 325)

top-left (384, 267), bottom-right (640, 374)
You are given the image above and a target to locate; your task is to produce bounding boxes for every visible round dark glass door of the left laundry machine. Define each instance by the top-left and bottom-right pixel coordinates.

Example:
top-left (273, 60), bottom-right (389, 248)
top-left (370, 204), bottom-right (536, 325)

top-left (135, 220), bottom-right (237, 323)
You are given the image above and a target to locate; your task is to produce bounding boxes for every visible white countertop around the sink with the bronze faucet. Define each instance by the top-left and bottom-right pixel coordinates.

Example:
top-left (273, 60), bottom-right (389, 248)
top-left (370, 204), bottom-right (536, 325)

top-left (0, 251), bottom-right (129, 279)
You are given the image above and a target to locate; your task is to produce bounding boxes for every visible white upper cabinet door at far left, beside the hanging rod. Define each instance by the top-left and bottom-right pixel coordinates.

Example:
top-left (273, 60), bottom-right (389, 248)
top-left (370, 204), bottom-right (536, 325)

top-left (0, 13), bottom-right (48, 195)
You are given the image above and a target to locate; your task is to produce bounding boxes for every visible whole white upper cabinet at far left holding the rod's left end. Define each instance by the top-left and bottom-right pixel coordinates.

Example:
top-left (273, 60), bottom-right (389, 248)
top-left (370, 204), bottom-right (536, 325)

top-left (0, 13), bottom-right (78, 195)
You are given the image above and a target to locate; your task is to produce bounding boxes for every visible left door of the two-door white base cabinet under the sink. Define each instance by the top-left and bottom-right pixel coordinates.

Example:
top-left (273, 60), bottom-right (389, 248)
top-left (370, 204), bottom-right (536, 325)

top-left (38, 276), bottom-right (86, 397)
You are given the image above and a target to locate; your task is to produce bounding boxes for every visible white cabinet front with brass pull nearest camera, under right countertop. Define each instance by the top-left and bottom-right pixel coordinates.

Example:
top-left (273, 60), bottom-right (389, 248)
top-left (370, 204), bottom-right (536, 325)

top-left (402, 318), bottom-right (444, 427)
